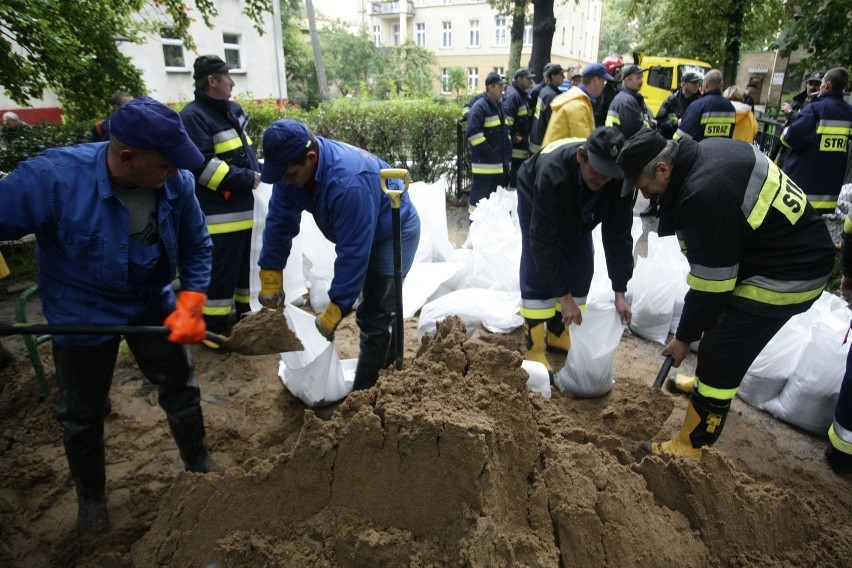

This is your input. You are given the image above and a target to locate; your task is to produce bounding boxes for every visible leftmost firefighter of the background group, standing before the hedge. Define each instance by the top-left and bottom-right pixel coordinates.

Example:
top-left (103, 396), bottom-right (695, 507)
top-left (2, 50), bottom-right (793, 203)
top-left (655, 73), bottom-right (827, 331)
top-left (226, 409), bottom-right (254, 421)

top-left (467, 71), bottom-right (512, 210)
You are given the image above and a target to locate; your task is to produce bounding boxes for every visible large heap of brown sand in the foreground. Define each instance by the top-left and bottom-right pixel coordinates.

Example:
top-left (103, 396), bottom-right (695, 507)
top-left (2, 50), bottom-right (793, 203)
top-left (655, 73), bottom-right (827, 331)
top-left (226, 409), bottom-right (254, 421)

top-left (129, 318), bottom-right (852, 567)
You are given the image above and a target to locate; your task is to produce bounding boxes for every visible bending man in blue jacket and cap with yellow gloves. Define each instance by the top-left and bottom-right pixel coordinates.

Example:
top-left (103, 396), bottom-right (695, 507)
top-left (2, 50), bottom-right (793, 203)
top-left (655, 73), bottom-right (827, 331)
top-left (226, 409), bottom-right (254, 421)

top-left (258, 119), bottom-right (420, 390)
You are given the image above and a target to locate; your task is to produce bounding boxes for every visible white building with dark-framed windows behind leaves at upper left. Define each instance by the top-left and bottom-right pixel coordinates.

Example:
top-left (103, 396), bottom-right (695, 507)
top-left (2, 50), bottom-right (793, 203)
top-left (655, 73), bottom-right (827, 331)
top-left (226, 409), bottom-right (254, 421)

top-left (0, 0), bottom-right (287, 122)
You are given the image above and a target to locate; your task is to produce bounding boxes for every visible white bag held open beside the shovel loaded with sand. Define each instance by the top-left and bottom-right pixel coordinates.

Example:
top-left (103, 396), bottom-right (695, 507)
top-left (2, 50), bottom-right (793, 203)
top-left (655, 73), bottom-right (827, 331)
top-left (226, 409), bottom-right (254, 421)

top-left (278, 305), bottom-right (354, 407)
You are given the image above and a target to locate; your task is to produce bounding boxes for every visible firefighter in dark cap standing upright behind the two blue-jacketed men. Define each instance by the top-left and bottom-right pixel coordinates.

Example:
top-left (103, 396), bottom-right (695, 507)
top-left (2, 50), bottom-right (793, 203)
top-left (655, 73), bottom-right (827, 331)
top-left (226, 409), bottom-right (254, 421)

top-left (180, 55), bottom-right (260, 349)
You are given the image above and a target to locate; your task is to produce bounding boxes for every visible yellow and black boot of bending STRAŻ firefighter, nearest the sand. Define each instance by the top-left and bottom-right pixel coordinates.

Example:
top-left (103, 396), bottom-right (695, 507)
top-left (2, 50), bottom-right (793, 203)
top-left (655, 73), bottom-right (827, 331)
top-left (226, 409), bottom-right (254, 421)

top-left (642, 391), bottom-right (731, 458)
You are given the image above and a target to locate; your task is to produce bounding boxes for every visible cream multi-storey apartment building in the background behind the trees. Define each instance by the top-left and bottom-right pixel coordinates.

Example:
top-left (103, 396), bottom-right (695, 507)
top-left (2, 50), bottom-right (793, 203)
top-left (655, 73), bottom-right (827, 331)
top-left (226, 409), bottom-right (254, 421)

top-left (359, 0), bottom-right (603, 95)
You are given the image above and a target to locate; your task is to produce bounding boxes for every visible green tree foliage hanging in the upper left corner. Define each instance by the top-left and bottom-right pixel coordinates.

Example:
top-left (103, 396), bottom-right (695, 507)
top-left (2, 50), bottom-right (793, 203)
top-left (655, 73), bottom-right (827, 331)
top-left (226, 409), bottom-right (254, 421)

top-left (0, 0), bottom-right (272, 119)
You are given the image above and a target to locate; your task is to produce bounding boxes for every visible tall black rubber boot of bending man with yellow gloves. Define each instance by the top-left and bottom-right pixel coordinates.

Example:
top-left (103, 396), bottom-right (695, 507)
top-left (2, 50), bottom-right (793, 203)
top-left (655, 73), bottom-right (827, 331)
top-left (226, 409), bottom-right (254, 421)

top-left (352, 272), bottom-right (395, 391)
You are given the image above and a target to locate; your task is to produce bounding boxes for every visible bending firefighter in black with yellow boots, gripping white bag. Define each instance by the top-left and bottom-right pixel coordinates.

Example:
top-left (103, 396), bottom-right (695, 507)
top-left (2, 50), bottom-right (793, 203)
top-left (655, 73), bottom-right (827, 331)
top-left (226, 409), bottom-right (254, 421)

top-left (518, 128), bottom-right (633, 373)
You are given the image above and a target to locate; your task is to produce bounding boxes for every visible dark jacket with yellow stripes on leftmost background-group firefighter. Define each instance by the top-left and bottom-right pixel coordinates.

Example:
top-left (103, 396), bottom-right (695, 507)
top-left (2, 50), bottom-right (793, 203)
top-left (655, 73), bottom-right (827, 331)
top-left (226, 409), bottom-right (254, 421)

top-left (467, 97), bottom-right (512, 175)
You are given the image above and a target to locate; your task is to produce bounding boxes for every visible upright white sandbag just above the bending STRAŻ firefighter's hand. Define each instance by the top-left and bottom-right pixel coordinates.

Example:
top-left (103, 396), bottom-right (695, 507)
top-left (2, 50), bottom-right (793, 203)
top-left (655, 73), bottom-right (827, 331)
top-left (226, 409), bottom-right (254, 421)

top-left (627, 257), bottom-right (682, 345)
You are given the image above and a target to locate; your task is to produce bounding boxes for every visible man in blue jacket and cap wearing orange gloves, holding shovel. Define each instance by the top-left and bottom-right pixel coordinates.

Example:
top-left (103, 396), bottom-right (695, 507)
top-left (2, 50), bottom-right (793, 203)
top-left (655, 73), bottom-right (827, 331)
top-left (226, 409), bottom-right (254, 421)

top-left (0, 97), bottom-right (221, 533)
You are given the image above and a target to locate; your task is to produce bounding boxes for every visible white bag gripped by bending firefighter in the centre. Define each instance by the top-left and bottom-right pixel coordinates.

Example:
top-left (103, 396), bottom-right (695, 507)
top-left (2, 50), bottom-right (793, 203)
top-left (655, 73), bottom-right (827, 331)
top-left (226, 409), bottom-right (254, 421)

top-left (555, 302), bottom-right (624, 398)
